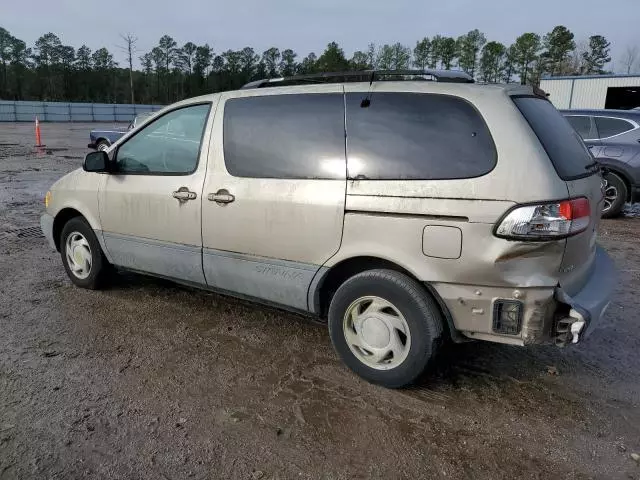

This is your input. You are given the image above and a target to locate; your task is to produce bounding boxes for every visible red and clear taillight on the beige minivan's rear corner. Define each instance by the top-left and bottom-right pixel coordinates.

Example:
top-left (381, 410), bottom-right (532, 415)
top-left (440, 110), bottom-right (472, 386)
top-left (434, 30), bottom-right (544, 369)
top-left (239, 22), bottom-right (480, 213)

top-left (495, 198), bottom-right (591, 240)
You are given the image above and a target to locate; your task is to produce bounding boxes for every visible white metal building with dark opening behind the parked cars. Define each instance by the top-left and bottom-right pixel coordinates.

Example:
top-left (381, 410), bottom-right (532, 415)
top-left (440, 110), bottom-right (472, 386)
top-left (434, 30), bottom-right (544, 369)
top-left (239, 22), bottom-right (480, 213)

top-left (540, 75), bottom-right (640, 110)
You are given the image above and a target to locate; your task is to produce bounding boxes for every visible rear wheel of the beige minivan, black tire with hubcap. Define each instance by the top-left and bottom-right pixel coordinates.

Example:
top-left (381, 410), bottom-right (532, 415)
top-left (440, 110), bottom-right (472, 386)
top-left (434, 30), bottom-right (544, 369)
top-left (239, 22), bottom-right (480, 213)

top-left (329, 270), bottom-right (443, 388)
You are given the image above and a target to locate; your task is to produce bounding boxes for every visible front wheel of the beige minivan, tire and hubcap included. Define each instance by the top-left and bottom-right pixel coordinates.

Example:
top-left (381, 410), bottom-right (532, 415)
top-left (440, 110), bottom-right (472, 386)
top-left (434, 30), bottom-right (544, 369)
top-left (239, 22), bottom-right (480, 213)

top-left (60, 217), bottom-right (110, 290)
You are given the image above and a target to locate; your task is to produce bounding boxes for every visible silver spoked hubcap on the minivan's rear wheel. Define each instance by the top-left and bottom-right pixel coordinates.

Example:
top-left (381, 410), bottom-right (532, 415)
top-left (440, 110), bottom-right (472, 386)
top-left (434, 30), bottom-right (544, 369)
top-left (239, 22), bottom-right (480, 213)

top-left (342, 296), bottom-right (411, 370)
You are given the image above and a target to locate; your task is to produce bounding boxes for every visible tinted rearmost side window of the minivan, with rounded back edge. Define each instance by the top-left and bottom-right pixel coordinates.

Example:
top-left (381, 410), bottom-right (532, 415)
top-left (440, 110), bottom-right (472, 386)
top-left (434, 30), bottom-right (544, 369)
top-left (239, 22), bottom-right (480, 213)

top-left (347, 92), bottom-right (497, 180)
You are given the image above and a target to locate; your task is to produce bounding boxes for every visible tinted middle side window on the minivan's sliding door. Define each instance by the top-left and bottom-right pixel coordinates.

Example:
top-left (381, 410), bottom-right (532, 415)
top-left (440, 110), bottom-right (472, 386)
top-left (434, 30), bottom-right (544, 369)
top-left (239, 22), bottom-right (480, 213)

top-left (224, 94), bottom-right (346, 179)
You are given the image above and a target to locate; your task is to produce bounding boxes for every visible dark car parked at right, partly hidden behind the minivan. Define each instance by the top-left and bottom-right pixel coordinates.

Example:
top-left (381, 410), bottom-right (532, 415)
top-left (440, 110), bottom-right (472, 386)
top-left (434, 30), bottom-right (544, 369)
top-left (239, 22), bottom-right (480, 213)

top-left (562, 110), bottom-right (640, 218)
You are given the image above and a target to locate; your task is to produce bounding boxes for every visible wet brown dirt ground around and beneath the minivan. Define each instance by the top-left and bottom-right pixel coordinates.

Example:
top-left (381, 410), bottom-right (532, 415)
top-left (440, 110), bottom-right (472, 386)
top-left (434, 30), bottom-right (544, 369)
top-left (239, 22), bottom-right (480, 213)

top-left (0, 124), bottom-right (640, 479)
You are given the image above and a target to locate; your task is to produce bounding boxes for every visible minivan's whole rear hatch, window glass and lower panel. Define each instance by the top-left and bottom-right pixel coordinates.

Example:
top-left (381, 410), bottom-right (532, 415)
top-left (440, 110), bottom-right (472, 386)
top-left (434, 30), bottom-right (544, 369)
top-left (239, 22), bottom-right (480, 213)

top-left (513, 96), bottom-right (603, 295)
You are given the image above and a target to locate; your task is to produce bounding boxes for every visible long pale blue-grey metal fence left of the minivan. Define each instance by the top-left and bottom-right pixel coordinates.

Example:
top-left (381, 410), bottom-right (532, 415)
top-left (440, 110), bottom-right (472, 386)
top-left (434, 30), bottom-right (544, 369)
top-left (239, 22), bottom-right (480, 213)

top-left (0, 100), bottom-right (162, 122)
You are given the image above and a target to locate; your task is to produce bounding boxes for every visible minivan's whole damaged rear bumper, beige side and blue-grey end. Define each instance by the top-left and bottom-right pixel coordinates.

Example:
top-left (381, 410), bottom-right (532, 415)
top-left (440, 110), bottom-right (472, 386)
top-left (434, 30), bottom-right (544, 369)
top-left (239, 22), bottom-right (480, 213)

top-left (431, 247), bottom-right (617, 346)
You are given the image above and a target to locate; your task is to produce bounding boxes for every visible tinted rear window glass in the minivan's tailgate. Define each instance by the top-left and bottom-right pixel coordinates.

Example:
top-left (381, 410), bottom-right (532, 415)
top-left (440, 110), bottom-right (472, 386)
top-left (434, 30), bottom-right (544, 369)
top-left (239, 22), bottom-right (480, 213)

top-left (513, 97), bottom-right (593, 180)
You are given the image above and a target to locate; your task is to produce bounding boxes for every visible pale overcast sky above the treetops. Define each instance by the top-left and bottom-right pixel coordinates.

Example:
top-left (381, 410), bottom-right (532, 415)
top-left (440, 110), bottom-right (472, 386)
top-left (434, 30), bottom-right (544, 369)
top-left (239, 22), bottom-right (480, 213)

top-left (0, 0), bottom-right (640, 69)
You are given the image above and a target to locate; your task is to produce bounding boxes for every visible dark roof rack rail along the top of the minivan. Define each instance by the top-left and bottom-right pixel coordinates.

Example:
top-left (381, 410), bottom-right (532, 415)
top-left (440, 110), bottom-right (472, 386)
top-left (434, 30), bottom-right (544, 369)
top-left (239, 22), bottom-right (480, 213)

top-left (241, 70), bottom-right (474, 90)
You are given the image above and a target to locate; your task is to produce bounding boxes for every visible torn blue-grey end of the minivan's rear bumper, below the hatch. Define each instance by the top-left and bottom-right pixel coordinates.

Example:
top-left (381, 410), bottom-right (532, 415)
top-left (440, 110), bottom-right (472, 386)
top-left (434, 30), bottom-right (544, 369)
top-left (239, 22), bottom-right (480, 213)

top-left (554, 247), bottom-right (618, 345)
